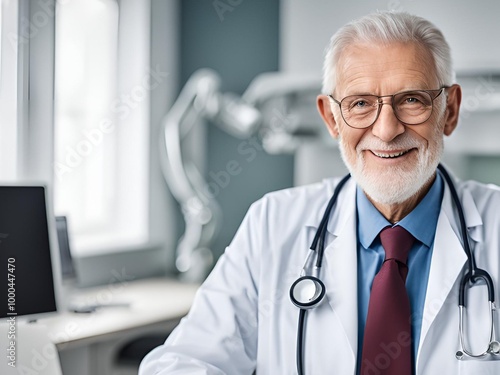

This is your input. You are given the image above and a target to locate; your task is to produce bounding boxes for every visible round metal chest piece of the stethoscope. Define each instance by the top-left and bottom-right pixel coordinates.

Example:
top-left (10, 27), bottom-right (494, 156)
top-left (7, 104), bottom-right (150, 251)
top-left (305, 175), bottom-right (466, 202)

top-left (290, 276), bottom-right (325, 309)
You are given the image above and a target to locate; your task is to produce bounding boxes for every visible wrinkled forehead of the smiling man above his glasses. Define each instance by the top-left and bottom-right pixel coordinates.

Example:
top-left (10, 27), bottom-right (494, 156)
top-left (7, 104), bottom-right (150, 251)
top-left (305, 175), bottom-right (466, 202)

top-left (335, 43), bottom-right (438, 97)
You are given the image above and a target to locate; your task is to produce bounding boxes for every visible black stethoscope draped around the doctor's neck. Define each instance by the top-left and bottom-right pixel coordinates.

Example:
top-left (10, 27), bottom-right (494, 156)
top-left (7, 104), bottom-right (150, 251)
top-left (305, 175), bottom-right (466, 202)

top-left (290, 164), bottom-right (500, 375)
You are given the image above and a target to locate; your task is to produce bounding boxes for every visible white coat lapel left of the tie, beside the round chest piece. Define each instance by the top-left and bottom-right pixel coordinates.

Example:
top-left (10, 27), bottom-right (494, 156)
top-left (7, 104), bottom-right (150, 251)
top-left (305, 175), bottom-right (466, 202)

top-left (323, 180), bottom-right (358, 366)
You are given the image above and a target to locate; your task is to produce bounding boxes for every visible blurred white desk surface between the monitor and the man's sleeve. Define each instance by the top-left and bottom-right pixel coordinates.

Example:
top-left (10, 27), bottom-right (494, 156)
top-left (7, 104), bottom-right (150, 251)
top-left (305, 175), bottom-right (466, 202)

top-left (39, 278), bottom-right (199, 347)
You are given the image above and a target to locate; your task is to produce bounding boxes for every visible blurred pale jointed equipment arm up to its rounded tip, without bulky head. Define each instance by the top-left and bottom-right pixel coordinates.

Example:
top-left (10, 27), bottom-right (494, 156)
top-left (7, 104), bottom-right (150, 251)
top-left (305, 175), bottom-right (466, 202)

top-left (160, 69), bottom-right (260, 281)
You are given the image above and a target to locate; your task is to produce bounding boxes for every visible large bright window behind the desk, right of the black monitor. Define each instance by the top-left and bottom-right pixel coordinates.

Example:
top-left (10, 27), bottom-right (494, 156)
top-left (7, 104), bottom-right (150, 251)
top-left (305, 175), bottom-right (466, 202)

top-left (54, 0), bottom-right (150, 256)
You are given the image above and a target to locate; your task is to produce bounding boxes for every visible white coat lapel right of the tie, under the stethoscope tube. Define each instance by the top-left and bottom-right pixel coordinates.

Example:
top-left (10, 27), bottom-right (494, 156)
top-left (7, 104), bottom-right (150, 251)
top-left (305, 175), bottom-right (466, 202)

top-left (418, 186), bottom-right (482, 362)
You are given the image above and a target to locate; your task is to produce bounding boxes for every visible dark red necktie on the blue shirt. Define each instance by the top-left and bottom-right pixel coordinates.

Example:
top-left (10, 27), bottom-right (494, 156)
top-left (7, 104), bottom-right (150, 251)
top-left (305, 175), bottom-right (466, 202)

top-left (360, 226), bottom-right (414, 375)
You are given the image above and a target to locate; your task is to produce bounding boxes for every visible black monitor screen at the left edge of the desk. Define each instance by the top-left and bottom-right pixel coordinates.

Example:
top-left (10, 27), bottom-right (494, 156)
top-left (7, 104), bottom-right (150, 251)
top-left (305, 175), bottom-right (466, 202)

top-left (0, 186), bottom-right (57, 318)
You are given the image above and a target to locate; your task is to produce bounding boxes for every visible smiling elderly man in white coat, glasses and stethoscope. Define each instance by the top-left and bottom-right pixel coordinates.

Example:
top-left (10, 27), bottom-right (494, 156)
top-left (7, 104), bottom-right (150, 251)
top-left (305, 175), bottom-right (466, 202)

top-left (139, 12), bottom-right (500, 375)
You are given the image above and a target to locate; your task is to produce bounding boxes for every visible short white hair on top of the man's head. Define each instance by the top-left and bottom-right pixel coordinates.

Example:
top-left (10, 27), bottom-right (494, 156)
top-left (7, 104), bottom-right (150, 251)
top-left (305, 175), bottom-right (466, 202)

top-left (322, 11), bottom-right (455, 95)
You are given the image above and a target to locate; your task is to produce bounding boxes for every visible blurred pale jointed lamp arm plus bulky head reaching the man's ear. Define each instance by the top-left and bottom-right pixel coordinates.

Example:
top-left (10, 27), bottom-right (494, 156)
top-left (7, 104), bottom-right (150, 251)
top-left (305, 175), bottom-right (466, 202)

top-left (160, 69), bottom-right (321, 281)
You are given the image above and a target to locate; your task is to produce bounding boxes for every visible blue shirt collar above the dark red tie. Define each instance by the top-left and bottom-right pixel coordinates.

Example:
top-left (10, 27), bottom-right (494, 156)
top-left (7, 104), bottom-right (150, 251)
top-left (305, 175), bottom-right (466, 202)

top-left (356, 173), bottom-right (443, 249)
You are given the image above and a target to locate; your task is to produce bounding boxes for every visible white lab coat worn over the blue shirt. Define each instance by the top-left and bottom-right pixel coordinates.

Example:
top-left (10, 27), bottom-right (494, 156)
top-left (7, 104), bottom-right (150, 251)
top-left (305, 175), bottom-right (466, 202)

top-left (139, 175), bottom-right (500, 375)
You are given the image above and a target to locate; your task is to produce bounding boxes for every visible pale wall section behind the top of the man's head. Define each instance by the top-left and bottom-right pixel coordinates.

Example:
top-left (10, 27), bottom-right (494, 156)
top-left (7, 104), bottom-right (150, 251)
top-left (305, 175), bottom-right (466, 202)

top-left (280, 0), bottom-right (500, 74)
